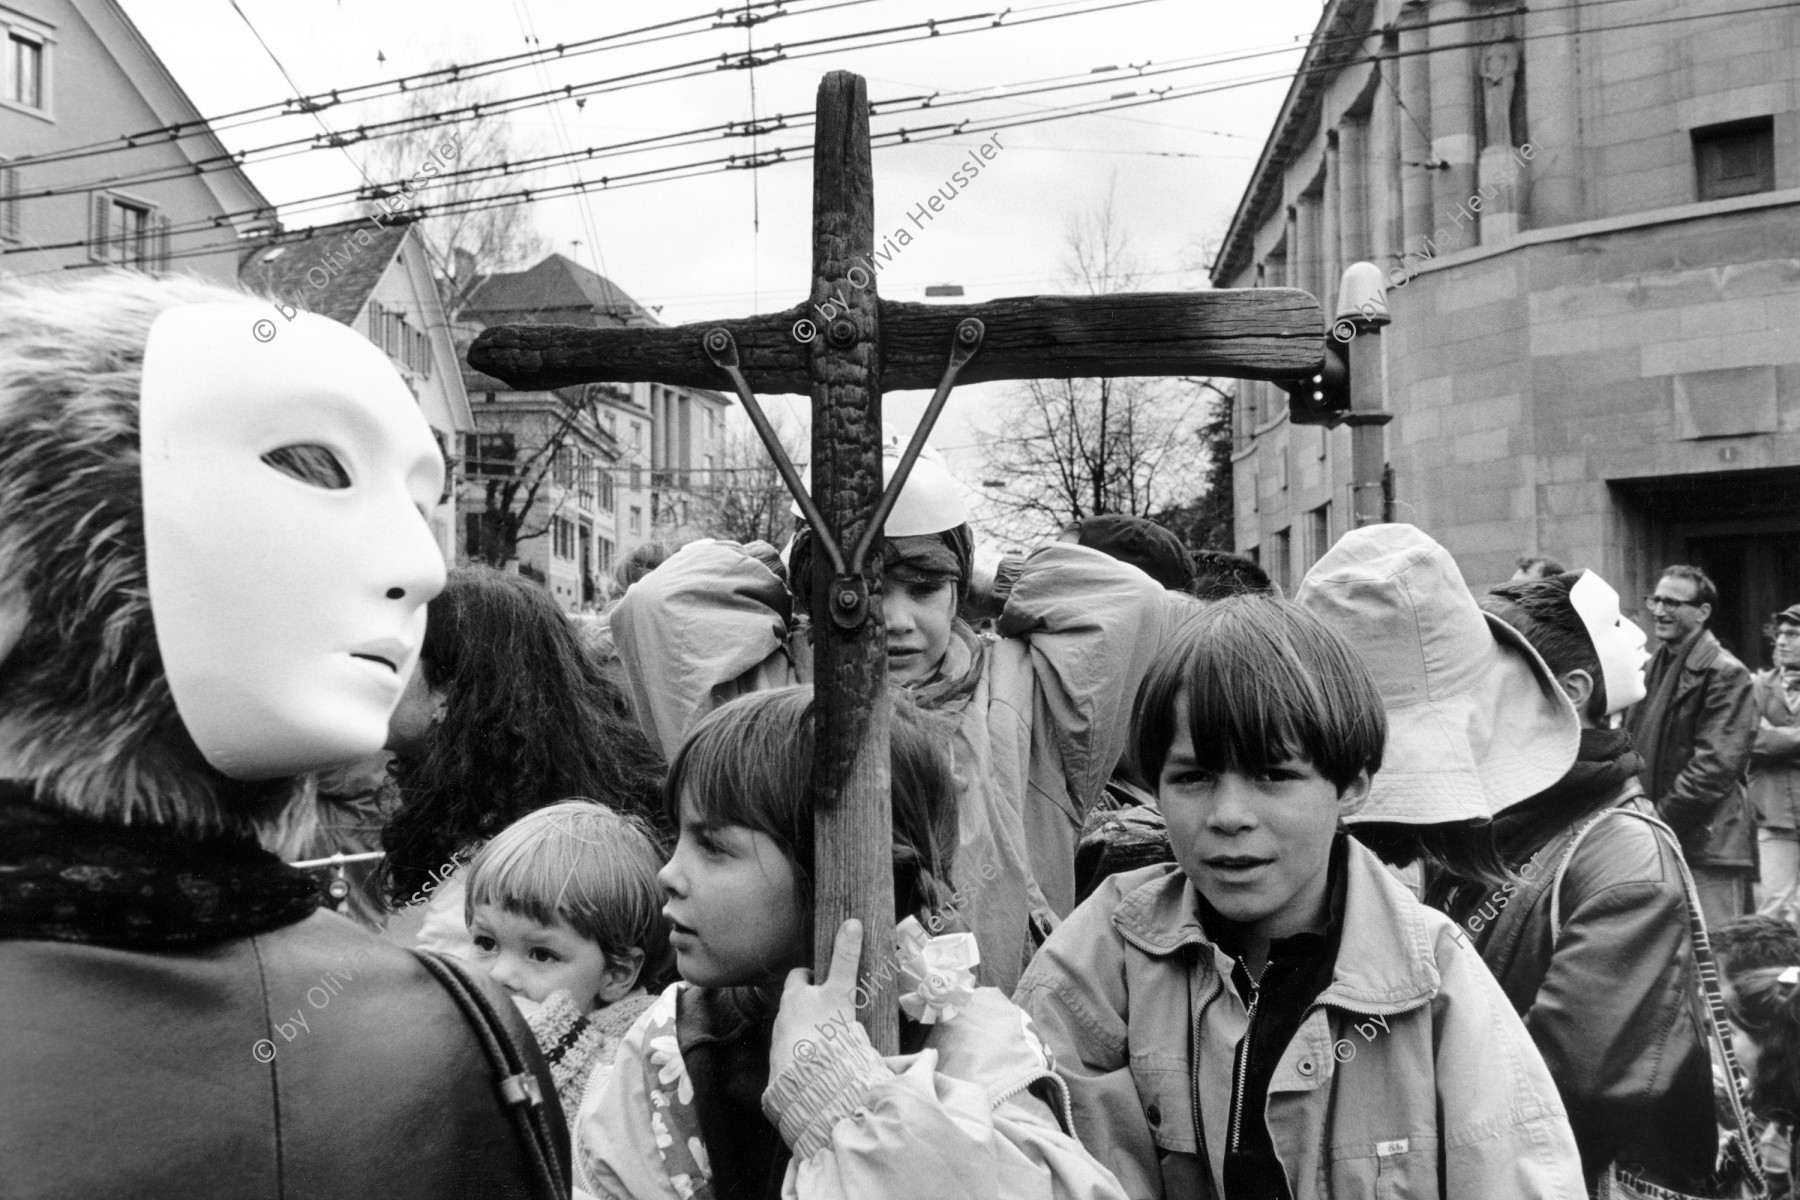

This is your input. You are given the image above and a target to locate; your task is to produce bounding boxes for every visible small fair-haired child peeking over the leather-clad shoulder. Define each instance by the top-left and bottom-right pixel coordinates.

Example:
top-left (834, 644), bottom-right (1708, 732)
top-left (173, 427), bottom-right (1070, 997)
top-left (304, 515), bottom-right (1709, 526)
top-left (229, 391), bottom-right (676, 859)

top-left (464, 799), bottom-right (670, 1124)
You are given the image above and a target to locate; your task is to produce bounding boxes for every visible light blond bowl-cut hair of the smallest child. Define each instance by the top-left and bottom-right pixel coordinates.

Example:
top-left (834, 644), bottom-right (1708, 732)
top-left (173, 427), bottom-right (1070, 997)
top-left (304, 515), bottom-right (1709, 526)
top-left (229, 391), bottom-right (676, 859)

top-left (463, 797), bottom-right (673, 988)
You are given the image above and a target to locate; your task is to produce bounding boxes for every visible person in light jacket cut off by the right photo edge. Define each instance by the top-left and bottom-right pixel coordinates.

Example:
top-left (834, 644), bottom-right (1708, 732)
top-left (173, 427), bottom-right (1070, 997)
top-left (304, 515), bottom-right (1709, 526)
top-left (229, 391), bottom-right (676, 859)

top-left (1750, 604), bottom-right (1800, 910)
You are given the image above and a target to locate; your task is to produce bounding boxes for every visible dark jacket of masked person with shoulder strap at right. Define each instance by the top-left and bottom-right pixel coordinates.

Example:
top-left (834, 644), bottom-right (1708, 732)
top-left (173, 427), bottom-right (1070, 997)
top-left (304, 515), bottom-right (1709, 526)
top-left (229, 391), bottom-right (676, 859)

top-left (1467, 801), bottom-right (1714, 1189)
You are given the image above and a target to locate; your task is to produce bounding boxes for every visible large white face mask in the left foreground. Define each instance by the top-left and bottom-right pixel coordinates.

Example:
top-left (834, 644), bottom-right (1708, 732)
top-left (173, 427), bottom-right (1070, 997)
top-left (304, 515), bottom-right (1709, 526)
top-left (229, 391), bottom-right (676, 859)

top-left (139, 302), bottom-right (445, 779)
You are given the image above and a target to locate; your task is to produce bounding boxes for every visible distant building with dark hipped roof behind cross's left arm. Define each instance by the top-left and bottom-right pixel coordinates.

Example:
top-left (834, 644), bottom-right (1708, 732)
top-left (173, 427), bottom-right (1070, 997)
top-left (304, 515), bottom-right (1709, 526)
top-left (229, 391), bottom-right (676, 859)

top-left (457, 254), bottom-right (731, 603)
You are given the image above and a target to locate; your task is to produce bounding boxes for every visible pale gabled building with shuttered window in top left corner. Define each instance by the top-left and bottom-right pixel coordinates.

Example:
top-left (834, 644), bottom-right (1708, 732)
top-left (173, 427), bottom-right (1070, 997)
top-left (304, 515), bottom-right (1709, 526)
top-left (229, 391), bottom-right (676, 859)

top-left (0, 0), bottom-right (275, 282)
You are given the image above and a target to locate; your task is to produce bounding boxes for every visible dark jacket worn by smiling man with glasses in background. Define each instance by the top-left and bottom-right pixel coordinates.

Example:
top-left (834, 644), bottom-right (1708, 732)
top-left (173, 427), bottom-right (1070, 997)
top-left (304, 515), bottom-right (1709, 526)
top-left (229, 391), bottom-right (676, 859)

top-left (1625, 630), bottom-right (1757, 871)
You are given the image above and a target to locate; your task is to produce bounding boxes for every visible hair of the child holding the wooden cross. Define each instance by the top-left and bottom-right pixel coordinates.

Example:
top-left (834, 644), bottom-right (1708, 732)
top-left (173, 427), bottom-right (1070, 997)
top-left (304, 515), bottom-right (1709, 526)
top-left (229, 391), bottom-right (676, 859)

top-left (664, 685), bottom-right (956, 916)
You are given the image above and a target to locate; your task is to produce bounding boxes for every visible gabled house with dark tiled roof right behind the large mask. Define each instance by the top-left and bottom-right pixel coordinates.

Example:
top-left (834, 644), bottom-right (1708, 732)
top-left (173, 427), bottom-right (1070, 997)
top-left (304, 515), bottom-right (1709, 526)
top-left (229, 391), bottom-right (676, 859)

top-left (238, 214), bottom-right (475, 563)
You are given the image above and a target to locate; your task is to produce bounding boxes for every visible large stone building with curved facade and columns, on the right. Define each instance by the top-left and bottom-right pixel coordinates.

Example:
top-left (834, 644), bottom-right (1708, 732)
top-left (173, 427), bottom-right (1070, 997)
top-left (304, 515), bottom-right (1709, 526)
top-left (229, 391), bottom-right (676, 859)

top-left (1213, 0), bottom-right (1800, 662)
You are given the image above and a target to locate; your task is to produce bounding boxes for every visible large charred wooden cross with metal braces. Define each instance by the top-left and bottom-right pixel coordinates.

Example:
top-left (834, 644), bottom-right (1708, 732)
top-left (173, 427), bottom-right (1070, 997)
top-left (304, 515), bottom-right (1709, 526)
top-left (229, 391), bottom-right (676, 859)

top-left (468, 72), bottom-right (1325, 1054)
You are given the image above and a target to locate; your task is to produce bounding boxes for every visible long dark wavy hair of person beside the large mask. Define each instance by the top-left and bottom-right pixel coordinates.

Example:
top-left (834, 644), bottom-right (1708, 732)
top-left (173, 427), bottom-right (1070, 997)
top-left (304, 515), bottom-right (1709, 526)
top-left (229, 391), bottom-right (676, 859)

top-left (382, 567), bottom-right (666, 898)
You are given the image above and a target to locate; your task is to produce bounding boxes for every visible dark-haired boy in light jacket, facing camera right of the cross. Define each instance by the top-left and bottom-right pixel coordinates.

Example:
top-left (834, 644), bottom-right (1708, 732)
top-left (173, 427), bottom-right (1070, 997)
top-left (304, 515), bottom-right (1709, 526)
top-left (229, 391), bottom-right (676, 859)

top-left (1015, 596), bottom-right (1586, 1200)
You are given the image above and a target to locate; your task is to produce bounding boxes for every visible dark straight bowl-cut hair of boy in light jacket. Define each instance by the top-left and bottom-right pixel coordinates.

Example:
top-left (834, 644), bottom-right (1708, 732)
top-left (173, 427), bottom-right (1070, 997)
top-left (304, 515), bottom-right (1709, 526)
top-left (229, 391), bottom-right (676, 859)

top-left (1132, 596), bottom-right (1388, 792)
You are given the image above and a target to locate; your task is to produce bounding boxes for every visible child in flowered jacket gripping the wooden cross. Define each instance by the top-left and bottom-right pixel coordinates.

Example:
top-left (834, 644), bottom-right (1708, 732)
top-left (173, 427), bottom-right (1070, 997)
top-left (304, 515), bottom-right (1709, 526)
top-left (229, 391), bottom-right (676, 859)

top-left (574, 687), bottom-right (1125, 1200)
